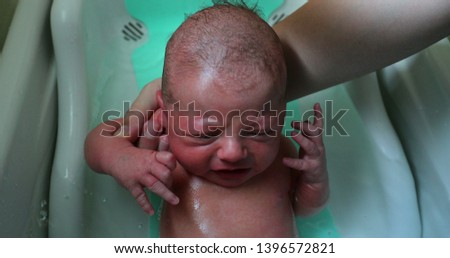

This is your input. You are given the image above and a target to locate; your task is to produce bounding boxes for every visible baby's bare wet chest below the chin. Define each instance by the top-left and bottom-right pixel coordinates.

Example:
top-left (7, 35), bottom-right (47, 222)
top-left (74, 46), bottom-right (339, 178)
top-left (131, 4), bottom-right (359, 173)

top-left (161, 174), bottom-right (296, 237)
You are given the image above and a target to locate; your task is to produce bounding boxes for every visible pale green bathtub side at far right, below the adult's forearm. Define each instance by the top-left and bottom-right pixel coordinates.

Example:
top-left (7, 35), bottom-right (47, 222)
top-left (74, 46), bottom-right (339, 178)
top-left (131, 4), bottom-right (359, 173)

top-left (378, 38), bottom-right (450, 237)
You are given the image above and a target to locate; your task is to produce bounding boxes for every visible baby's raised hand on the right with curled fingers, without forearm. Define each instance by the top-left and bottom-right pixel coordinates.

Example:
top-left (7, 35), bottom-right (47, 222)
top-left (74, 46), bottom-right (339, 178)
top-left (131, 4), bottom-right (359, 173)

top-left (283, 103), bottom-right (328, 184)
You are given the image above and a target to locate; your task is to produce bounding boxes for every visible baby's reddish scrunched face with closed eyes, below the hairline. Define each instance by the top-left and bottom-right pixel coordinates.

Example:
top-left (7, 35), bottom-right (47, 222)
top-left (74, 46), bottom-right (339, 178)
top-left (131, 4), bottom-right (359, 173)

top-left (166, 70), bottom-right (285, 187)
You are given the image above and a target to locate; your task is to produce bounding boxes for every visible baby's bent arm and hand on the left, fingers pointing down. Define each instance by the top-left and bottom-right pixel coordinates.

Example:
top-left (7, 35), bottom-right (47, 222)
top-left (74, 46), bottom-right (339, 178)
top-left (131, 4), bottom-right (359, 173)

top-left (85, 95), bottom-right (179, 214)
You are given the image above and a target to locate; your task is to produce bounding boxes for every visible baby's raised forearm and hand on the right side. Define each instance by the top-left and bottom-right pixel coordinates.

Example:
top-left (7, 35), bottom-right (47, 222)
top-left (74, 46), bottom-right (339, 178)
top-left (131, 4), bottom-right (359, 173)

top-left (283, 104), bottom-right (330, 216)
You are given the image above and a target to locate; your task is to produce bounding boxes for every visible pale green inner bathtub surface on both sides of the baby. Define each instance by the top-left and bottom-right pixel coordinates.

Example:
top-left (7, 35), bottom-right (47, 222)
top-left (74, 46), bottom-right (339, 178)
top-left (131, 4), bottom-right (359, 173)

top-left (49, 0), bottom-right (449, 237)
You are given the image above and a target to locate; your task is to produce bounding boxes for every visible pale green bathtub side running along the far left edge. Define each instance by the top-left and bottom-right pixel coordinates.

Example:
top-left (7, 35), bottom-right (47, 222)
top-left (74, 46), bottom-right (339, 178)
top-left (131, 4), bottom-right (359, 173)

top-left (0, 0), bottom-right (57, 237)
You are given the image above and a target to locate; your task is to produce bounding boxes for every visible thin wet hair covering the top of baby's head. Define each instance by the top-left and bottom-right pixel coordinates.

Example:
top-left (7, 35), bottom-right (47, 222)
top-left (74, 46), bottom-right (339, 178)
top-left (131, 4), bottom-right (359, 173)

top-left (162, 0), bottom-right (286, 103)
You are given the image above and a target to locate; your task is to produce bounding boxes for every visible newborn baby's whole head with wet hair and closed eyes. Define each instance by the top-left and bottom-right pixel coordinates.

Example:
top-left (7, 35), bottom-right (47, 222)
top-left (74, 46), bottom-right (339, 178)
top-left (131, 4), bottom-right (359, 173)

top-left (158, 4), bottom-right (286, 187)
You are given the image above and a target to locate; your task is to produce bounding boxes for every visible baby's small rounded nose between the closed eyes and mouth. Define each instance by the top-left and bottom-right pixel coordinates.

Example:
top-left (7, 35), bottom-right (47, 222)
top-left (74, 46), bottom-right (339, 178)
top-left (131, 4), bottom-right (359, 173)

top-left (217, 137), bottom-right (248, 162)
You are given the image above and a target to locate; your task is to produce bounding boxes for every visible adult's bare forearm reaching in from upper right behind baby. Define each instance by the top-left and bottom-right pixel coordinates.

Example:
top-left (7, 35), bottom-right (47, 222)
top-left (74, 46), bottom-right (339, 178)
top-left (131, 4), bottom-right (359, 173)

top-left (274, 0), bottom-right (450, 100)
